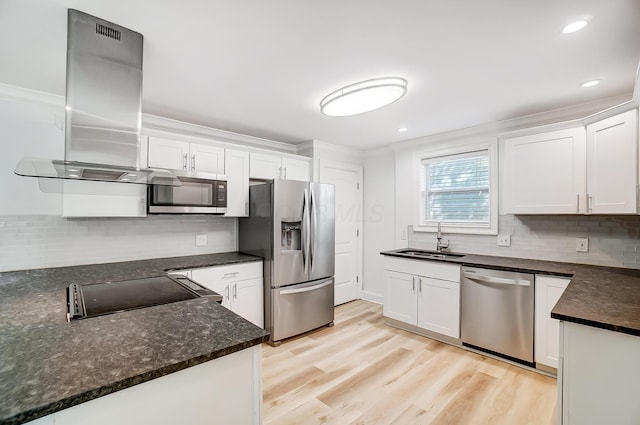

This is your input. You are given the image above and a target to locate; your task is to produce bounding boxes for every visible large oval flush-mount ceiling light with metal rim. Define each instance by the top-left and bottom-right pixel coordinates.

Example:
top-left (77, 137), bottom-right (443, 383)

top-left (320, 77), bottom-right (407, 117)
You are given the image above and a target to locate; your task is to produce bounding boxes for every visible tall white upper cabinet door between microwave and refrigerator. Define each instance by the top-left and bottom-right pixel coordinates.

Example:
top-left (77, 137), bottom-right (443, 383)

top-left (224, 149), bottom-right (249, 217)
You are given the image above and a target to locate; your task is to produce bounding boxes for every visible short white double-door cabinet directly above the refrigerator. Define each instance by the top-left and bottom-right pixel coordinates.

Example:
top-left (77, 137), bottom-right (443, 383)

top-left (249, 152), bottom-right (311, 181)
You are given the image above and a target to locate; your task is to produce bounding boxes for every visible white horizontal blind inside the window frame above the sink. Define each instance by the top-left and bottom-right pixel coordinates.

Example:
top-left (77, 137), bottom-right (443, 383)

top-left (420, 150), bottom-right (491, 226)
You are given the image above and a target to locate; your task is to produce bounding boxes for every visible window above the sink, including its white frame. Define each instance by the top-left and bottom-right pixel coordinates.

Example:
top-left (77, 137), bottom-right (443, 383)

top-left (414, 145), bottom-right (497, 234)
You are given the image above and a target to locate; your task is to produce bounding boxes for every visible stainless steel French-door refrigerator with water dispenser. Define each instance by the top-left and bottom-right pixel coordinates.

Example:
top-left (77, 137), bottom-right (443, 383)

top-left (238, 180), bottom-right (335, 345)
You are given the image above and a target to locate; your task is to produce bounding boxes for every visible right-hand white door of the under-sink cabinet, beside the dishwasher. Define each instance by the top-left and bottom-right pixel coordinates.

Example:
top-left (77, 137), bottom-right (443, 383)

top-left (417, 276), bottom-right (460, 338)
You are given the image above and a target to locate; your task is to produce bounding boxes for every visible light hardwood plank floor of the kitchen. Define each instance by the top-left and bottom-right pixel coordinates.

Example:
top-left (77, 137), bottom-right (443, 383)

top-left (262, 301), bottom-right (556, 425)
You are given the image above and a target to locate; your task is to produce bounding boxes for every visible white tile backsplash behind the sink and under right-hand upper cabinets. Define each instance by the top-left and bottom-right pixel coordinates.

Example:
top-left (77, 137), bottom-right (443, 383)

top-left (408, 215), bottom-right (640, 268)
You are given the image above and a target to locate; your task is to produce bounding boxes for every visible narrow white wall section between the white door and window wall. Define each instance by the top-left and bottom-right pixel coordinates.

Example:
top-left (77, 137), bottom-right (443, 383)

top-left (362, 149), bottom-right (395, 303)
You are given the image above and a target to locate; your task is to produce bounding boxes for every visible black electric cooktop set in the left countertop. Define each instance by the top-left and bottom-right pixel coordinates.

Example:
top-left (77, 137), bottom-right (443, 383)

top-left (67, 275), bottom-right (222, 320)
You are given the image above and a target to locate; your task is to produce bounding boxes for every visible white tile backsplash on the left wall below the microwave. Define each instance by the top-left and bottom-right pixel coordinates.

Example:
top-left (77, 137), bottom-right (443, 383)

top-left (0, 215), bottom-right (237, 272)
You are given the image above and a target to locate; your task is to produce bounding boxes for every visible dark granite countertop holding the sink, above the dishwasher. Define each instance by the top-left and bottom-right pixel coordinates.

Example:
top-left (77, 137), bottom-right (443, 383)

top-left (381, 249), bottom-right (640, 336)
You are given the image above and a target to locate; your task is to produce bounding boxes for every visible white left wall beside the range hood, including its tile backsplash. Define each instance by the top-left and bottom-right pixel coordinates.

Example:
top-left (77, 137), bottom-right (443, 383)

top-left (0, 90), bottom-right (237, 272)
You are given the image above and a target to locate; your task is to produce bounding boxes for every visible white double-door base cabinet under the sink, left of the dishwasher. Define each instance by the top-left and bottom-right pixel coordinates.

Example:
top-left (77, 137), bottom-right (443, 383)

top-left (383, 257), bottom-right (460, 338)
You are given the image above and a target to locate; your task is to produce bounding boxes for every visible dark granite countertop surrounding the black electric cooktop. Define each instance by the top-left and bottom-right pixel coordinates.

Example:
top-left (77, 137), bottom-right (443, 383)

top-left (0, 252), bottom-right (268, 424)
